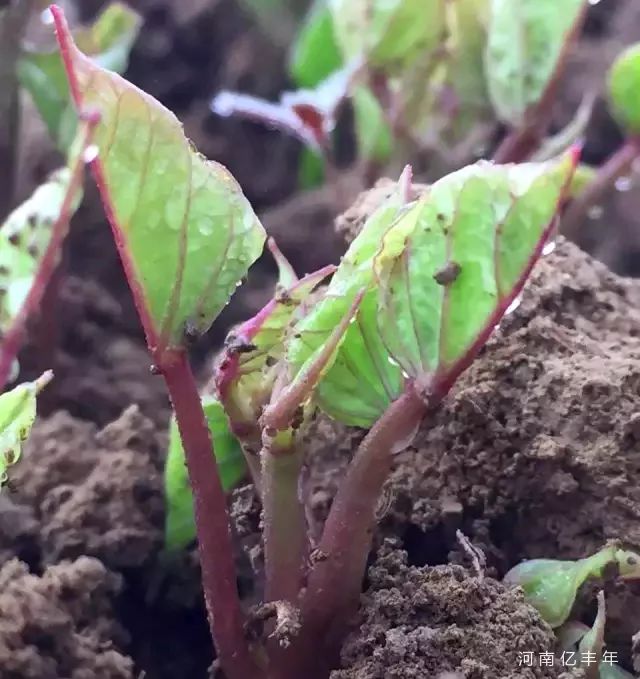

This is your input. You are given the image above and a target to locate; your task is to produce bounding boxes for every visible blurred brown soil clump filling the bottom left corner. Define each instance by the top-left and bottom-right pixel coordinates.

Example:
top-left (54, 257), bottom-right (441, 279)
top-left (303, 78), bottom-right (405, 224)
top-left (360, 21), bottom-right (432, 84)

top-left (0, 557), bottom-right (134, 679)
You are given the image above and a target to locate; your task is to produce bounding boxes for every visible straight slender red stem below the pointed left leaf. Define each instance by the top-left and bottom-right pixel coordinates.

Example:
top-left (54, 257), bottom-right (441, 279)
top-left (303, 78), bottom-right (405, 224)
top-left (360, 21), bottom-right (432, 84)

top-left (156, 350), bottom-right (260, 679)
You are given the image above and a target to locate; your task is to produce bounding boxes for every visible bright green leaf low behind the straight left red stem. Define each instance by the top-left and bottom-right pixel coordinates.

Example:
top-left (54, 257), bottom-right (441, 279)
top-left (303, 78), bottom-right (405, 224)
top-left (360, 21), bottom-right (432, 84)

top-left (164, 397), bottom-right (246, 551)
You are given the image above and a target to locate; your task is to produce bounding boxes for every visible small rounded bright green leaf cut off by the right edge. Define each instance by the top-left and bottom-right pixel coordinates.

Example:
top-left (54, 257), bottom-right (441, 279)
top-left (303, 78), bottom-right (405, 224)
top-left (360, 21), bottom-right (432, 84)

top-left (608, 43), bottom-right (640, 134)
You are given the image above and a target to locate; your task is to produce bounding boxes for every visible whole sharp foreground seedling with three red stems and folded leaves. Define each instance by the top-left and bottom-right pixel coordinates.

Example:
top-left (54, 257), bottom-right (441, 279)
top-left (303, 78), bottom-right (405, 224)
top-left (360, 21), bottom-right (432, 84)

top-left (52, 2), bottom-right (577, 679)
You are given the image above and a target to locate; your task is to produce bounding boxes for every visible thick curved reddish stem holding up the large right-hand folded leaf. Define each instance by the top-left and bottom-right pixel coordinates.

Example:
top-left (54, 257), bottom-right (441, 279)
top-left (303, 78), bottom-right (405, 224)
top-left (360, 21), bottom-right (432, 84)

top-left (278, 384), bottom-right (427, 679)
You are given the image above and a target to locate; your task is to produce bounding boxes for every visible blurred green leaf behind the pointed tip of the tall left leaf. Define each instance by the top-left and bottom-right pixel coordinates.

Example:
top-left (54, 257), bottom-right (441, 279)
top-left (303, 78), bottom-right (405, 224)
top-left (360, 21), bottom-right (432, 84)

top-left (18, 2), bottom-right (142, 150)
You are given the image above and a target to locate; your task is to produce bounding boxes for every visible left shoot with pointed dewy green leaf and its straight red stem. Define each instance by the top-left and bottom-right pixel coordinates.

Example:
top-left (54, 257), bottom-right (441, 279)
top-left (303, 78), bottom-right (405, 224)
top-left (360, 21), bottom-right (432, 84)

top-left (51, 6), bottom-right (265, 679)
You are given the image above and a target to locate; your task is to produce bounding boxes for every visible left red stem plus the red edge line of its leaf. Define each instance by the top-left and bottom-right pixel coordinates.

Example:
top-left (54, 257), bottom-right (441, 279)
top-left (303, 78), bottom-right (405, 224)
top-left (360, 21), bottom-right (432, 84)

top-left (50, 5), bottom-right (260, 679)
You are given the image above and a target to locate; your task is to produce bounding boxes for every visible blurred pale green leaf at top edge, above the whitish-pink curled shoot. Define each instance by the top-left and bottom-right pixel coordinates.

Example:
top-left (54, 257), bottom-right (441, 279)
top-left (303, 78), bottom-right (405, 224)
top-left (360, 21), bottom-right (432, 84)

top-left (328, 0), bottom-right (446, 70)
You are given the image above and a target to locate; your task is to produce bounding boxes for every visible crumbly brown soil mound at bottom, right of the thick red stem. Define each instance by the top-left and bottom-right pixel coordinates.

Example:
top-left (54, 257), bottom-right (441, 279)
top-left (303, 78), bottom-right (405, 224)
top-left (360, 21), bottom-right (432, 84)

top-left (331, 549), bottom-right (559, 679)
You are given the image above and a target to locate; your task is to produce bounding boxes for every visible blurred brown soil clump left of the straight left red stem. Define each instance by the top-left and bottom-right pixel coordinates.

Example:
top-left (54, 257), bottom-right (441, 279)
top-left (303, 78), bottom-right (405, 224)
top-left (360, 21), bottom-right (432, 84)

top-left (12, 406), bottom-right (163, 570)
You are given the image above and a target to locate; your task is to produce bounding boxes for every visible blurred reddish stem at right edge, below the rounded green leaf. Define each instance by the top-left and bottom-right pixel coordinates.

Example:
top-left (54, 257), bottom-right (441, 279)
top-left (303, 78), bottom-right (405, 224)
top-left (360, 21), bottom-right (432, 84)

top-left (560, 136), bottom-right (640, 241)
